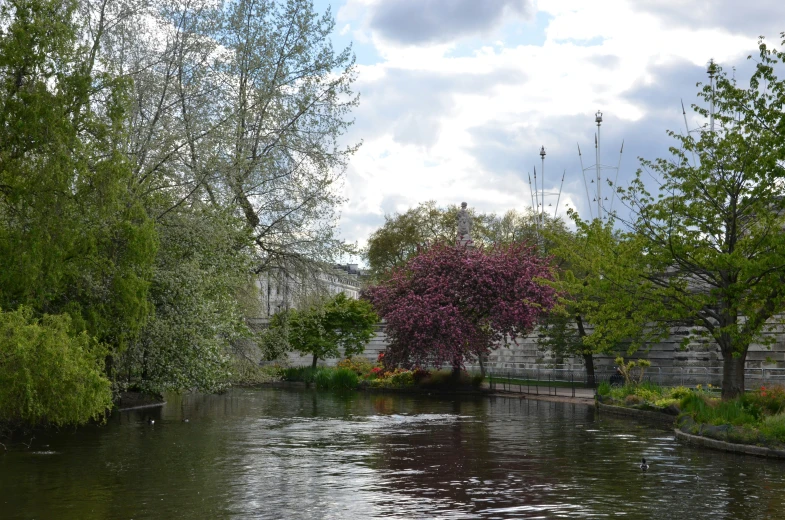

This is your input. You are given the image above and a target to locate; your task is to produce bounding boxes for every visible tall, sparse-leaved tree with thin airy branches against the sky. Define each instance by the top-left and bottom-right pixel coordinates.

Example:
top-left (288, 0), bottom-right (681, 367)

top-left (93, 0), bottom-right (358, 271)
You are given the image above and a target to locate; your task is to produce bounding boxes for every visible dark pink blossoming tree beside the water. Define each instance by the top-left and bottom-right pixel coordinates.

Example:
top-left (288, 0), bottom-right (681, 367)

top-left (365, 244), bottom-right (556, 373)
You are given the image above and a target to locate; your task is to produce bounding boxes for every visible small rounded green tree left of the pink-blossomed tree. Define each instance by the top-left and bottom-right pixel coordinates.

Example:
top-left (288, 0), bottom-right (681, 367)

top-left (271, 293), bottom-right (379, 367)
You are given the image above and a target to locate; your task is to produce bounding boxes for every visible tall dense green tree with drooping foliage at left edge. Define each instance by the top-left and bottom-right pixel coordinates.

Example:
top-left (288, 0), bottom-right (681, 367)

top-left (0, 0), bottom-right (157, 370)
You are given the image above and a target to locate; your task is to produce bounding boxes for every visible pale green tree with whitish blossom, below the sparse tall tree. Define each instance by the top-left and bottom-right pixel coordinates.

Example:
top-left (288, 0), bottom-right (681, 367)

top-left (118, 206), bottom-right (260, 393)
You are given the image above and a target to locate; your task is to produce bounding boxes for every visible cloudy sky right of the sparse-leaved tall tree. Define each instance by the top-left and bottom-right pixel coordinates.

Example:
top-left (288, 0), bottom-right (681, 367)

top-left (315, 0), bottom-right (785, 254)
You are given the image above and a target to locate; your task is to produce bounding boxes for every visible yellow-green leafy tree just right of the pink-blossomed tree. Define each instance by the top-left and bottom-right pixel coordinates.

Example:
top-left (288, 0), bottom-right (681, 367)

top-left (538, 217), bottom-right (670, 384)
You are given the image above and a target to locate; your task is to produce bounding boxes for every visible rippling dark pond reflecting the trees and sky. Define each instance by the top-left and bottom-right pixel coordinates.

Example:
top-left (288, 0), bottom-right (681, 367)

top-left (0, 388), bottom-right (785, 520)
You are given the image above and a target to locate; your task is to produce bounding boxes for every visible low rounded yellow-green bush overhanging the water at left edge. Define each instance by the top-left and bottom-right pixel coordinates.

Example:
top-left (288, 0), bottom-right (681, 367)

top-left (0, 307), bottom-right (112, 426)
